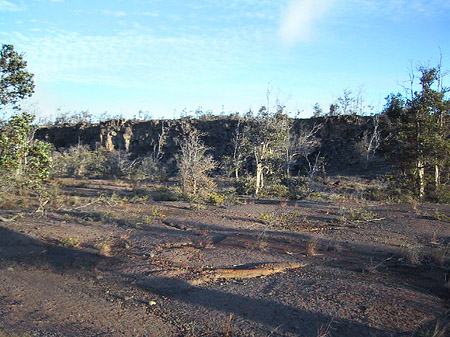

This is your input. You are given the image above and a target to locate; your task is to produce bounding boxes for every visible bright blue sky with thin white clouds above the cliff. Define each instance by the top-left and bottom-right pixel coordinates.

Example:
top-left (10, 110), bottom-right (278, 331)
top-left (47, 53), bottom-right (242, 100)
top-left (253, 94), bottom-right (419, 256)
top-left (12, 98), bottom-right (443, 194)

top-left (0, 0), bottom-right (450, 118)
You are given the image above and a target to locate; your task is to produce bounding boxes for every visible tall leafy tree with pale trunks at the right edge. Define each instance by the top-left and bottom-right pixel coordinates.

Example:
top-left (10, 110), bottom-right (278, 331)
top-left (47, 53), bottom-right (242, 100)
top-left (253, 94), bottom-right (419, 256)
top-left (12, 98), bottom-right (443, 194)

top-left (384, 66), bottom-right (450, 199)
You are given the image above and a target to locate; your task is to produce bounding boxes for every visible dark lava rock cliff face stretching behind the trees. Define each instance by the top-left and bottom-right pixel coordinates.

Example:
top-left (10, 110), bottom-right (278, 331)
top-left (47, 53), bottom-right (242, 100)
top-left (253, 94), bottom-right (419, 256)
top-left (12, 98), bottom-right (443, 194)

top-left (36, 115), bottom-right (385, 173)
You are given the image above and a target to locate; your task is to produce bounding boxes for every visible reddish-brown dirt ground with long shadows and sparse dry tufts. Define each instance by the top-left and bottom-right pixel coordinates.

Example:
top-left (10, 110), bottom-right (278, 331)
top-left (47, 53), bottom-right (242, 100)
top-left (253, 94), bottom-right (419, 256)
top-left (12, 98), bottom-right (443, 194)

top-left (0, 179), bottom-right (450, 337)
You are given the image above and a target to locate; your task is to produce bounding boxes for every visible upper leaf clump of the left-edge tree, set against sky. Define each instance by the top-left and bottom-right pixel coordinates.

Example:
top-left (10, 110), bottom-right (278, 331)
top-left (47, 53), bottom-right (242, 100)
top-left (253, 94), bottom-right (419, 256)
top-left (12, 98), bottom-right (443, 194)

top-left (0, 44), bottom-right (34, 106)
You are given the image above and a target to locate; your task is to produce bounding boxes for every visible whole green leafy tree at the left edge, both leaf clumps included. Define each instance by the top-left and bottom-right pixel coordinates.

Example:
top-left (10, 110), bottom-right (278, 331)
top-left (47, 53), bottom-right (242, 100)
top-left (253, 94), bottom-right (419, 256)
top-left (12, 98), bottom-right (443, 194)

top-left (0, 45), bottom-right (51, 188)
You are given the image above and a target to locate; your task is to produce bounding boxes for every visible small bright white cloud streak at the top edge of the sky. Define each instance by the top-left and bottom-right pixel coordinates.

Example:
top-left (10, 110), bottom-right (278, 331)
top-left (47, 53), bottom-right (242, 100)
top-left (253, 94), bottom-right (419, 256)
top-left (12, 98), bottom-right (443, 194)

top-left (279, 0), bottom-right (334, 46)
